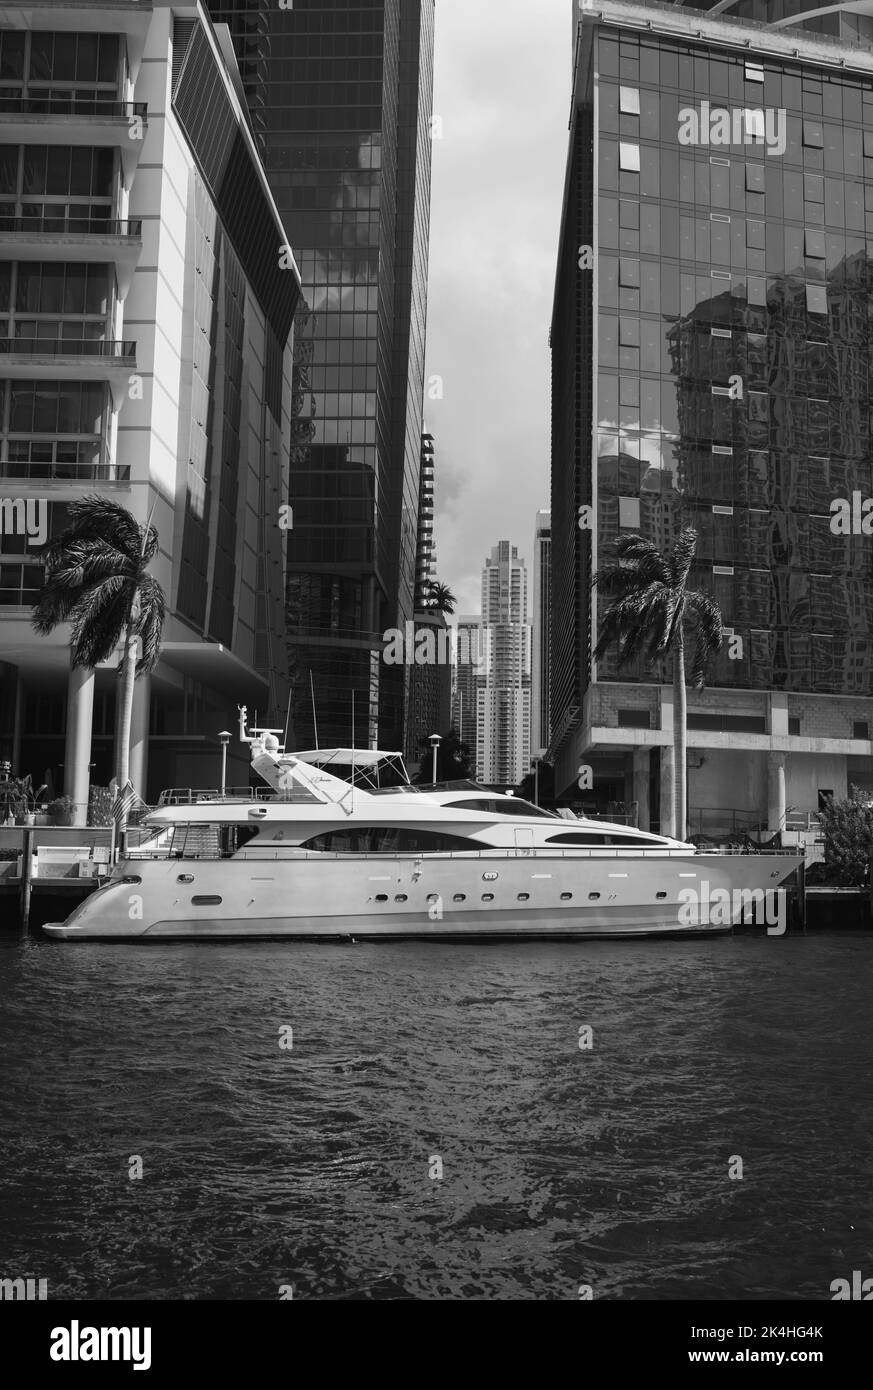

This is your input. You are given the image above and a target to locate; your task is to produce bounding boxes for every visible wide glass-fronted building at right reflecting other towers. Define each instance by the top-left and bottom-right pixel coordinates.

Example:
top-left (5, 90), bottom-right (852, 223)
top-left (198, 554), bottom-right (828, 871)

top-left (550, 0), bottom-right (873, 834)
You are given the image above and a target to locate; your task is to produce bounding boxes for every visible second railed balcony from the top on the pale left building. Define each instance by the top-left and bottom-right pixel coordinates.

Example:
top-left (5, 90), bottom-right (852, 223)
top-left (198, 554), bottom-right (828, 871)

top-left (0, 210), bottom-right (142, 299)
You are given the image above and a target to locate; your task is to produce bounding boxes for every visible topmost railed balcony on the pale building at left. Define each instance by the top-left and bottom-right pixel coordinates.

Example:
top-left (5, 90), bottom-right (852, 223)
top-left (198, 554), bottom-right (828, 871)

top-left (0, 98), bottom-right (149, 188)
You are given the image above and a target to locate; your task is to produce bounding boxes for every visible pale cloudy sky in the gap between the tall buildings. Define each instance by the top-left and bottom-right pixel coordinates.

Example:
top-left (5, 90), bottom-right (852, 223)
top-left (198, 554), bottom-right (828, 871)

top-left (424, 0), bottom-right (571, 613)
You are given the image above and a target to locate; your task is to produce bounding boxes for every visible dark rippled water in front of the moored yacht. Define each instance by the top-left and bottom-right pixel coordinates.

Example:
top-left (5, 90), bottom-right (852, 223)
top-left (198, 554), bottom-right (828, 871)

top-left (0, 934), bottom-right (873, 1300)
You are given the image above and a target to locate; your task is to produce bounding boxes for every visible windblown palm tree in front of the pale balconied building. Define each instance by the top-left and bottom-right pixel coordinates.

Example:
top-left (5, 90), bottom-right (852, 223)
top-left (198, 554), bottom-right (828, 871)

top-left (31, 495), bottom-right (164, 791)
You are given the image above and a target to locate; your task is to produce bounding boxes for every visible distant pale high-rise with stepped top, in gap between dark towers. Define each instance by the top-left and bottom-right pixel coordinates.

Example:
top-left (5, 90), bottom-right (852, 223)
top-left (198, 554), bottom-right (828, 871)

top-left (475, 541), bottom-right (531, 787)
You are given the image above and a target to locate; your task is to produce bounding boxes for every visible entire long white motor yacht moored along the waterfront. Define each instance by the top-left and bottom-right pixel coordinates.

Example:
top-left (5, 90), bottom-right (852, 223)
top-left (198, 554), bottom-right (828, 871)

top-left (44, 706), bottom-right (801, 941)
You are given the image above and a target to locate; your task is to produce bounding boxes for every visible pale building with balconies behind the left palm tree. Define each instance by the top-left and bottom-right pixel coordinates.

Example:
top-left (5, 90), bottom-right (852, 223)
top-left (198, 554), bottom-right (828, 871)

top-left (0, 0), bottom-right (299, 815)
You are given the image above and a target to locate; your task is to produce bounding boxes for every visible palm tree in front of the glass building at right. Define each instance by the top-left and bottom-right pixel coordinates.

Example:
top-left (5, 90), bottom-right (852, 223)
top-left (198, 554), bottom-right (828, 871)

top-left (594, 527), bottom-right (724, 840)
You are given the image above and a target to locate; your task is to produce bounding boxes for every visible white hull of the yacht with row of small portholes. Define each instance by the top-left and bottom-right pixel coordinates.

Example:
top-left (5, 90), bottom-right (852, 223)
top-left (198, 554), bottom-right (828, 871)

top-left (43, 851), bottom-right (801, 941)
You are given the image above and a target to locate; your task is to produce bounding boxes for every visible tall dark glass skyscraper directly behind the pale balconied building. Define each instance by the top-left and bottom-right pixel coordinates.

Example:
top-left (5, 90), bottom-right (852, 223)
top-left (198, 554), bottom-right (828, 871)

top-left (210, 0), bottom-right (434, 748)
